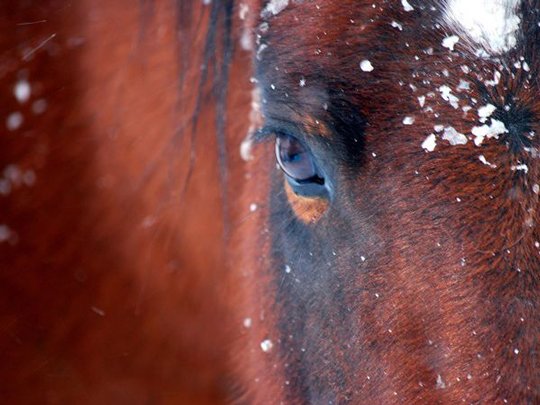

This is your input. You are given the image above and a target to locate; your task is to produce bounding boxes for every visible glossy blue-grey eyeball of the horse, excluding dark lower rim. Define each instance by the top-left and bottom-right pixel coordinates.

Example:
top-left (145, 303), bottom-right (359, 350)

top-left (276, 135), bottom-right (317, 181)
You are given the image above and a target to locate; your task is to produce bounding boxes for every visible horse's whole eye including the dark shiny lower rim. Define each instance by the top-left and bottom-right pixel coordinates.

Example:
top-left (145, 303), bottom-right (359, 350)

top-left (276, 135), bottom-right (325, 195)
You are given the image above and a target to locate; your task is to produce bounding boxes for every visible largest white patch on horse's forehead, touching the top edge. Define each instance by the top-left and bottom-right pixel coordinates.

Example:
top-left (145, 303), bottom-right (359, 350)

top-left (444, 0), bottom-right (521, 56)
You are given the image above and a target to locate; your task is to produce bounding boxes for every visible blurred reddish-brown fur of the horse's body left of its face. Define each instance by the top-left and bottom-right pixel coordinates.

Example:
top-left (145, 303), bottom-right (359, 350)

top-left (0, 0), bottom-right (249, 404)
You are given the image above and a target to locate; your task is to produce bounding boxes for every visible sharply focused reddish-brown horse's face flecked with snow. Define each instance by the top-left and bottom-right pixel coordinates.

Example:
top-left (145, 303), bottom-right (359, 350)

top-left (238, 0), bottom-right (540, 404)
